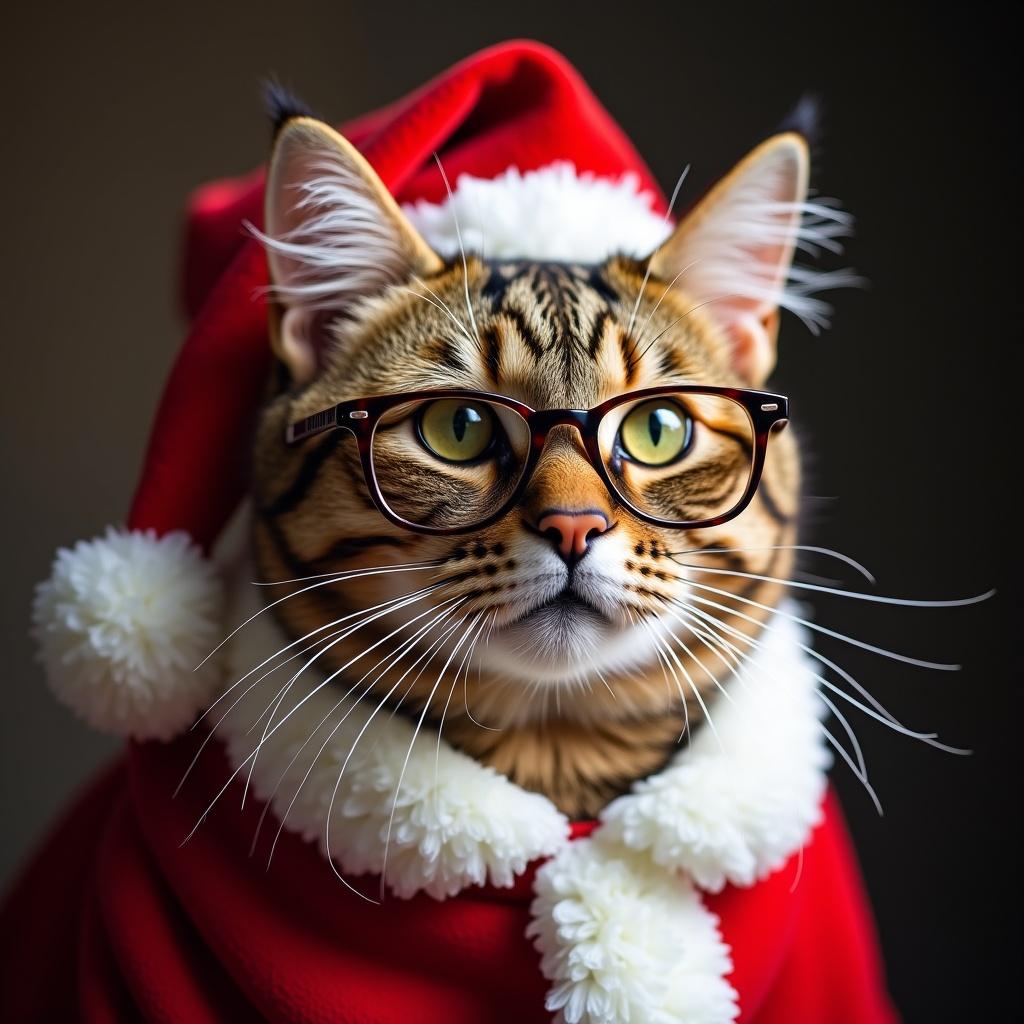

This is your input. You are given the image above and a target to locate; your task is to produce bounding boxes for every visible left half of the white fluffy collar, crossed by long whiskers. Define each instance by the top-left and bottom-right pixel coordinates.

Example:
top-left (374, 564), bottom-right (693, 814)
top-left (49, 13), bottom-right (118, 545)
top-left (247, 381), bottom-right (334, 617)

top-left (218, 581), bottom-right (568, 899)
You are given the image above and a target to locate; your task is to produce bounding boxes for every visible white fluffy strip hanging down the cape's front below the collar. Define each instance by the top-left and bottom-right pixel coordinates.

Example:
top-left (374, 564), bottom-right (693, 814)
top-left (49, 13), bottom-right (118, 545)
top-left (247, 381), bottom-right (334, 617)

top-left (526, 840), bottom-right (738, 1024)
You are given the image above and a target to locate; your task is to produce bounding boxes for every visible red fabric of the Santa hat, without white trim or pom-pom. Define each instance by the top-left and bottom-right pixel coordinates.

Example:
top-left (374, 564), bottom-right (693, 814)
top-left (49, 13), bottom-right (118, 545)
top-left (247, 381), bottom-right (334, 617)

top-left (128, 42), bottom-right (660, 547)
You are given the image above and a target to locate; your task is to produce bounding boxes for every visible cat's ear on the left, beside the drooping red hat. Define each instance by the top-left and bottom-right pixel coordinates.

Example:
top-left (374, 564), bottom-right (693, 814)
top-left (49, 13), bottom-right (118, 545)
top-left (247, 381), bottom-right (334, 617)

top-left (261, 117), bottom-right (443, 383)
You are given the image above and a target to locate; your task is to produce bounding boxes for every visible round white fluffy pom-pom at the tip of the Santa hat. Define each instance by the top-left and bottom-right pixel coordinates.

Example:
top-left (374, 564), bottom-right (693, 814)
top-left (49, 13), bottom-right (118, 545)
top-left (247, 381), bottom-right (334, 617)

top-left (32, 528), bottom-right (222, 739)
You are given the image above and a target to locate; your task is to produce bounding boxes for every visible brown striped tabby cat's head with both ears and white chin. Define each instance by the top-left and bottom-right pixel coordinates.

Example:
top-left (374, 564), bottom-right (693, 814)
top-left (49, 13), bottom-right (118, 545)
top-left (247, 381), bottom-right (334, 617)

top-left (254, 117), bottom-right (823, 753)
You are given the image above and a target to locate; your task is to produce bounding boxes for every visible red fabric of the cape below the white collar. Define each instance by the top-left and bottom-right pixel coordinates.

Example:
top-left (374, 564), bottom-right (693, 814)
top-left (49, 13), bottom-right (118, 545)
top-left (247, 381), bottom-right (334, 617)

top-left (0, 735), bottom-right (895, 1024)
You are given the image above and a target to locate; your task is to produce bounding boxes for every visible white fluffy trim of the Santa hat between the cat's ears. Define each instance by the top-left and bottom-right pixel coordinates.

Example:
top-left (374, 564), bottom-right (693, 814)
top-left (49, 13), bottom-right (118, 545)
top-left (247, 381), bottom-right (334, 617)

top-left (402, 161), bottom-right (672, 263)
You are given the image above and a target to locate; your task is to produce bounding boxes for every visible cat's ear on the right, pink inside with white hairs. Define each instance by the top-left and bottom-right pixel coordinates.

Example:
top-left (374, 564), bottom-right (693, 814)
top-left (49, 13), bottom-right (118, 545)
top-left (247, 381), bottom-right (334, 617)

top-left (650, 132), bottom-right (808, 384)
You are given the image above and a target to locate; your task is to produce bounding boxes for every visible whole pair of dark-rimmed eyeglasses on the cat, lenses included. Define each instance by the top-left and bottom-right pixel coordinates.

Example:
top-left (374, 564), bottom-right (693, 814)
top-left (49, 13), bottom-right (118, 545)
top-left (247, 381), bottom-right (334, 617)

top-left (285, 385), bottom-right (790, 536)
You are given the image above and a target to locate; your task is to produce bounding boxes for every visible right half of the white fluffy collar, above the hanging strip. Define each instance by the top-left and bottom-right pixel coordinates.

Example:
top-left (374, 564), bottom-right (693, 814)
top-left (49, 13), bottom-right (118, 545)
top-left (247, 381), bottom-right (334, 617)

top-left (601, 615), bottom-right (830, 892)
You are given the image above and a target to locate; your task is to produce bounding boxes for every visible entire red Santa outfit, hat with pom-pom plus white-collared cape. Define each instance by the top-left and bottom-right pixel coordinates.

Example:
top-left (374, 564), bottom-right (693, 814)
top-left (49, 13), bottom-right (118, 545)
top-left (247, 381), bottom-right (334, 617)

top-left (0, 43), bottom-right (895, 1024)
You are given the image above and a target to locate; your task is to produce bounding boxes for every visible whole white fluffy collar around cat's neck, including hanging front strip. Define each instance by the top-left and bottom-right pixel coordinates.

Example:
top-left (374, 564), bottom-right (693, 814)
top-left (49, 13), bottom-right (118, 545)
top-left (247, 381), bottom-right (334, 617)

top-left (215, 561), bottom-right (829, 1024)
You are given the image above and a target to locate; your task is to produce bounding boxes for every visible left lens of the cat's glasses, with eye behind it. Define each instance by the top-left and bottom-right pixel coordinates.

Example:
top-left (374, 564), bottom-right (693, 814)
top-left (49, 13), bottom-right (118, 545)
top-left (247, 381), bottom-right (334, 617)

top-left (371, 398), bottom-right (529, 529)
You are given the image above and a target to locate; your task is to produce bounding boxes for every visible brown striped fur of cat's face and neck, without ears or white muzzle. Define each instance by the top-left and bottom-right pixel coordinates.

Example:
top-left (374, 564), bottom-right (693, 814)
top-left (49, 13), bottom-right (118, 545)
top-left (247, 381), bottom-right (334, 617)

top-left (254, 245), bottom-right (799, 816)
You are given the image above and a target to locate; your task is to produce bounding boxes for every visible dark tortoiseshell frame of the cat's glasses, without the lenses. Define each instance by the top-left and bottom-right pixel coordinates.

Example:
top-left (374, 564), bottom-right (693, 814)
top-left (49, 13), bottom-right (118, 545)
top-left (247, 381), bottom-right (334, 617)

top-left (285, 384), bottom-right (790, 536)
